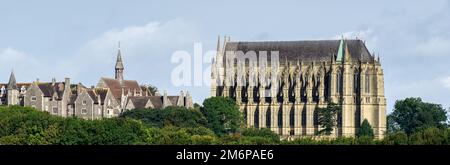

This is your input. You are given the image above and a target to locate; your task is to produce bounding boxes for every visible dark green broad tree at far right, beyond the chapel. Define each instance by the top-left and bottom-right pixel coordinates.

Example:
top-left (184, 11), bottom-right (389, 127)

top-left (391, 98), bottom-right (447, 135)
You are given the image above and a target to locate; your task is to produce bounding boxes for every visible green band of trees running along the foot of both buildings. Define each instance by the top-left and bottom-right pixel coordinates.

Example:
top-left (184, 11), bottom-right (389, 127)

top-left (0, 97), bottom-right (450, 145)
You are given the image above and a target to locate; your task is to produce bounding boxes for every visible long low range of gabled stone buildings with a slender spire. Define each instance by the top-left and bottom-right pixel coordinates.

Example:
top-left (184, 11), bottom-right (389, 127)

top-left (0, 43), bottom-right (193, 119)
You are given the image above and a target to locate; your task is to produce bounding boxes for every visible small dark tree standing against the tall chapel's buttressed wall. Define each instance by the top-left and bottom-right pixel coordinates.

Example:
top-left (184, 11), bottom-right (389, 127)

top-left (316, 103), bottom-right (342, 135)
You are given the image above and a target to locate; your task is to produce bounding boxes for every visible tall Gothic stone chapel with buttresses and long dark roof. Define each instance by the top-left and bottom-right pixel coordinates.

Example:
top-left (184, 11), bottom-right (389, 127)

top-left (211, 37), bottom-right (386, 138)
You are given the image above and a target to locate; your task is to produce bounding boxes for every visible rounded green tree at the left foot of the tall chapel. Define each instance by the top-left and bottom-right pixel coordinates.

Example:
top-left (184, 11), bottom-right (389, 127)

top-left (201, 97), bottom-right (243, 135)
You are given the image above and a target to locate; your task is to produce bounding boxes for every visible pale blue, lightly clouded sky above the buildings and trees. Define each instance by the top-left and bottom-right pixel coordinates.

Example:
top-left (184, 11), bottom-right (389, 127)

top-left (0, 0), bottom-right (450, 112)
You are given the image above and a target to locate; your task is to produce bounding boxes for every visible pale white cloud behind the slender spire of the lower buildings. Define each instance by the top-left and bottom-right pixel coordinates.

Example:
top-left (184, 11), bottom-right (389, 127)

top-left (62, 19), bottom-right (196, 81)
